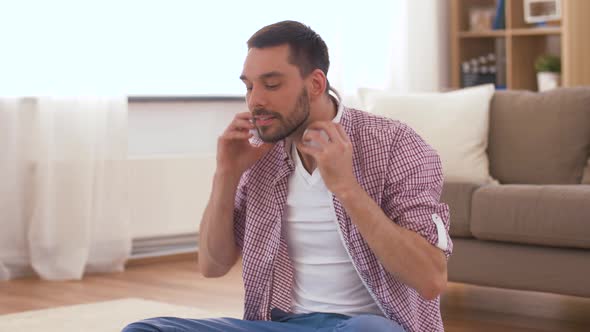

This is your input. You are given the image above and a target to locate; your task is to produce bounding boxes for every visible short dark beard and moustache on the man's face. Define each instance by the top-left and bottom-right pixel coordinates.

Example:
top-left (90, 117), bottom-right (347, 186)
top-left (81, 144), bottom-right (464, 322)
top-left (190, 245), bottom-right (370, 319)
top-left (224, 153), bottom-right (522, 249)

top-left (253, 88), bottom-right (310, 143)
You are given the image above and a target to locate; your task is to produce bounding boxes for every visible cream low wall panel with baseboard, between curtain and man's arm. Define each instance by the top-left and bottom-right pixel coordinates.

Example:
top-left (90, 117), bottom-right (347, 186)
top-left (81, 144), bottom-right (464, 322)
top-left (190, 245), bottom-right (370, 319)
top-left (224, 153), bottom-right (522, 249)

top-left (129, 154), bottom-right (215, 257)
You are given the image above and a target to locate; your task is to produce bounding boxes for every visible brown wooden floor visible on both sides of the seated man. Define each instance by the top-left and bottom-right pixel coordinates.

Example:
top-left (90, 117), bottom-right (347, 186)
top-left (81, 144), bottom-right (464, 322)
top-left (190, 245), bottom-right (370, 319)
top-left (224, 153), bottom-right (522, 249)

top-left (0, 256), bottom-right (590, 332)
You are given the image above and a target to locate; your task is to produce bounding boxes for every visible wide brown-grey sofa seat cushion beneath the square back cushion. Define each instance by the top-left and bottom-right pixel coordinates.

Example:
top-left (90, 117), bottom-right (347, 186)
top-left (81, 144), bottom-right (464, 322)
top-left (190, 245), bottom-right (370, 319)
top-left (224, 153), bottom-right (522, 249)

top-left (471, 185), bottom-right (590, 248)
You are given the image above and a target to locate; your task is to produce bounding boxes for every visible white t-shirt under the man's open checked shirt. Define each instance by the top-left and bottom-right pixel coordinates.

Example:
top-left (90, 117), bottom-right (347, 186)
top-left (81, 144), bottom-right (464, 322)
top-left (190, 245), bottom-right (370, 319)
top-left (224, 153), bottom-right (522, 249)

top-left (282, 104), bottom-right (383, 316)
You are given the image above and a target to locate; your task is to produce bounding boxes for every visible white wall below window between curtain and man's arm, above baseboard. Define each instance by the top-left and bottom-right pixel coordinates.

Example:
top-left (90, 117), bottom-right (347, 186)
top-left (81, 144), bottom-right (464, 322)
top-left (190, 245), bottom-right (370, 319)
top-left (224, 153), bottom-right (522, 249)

top-left (129, 101), bottom-right (246, 238)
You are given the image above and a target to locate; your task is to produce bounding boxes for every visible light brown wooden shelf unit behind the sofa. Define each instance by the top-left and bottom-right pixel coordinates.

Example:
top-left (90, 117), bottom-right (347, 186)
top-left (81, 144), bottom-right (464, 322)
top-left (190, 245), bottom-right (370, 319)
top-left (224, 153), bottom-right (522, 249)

top-left (449, 0), bottom-right (590, 91)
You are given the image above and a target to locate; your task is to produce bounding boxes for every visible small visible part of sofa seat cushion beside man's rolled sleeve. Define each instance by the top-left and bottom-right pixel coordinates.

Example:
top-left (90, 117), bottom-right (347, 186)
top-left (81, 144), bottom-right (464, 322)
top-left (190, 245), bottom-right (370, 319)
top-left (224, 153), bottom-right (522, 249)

top-left (440, 182), bottom-right (480, 237)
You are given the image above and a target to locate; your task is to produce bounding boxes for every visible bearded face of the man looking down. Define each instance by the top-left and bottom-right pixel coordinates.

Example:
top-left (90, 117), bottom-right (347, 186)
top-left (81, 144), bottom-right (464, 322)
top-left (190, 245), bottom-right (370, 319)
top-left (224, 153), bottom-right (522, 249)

top-left (240, 45), bottom-right (310, 142)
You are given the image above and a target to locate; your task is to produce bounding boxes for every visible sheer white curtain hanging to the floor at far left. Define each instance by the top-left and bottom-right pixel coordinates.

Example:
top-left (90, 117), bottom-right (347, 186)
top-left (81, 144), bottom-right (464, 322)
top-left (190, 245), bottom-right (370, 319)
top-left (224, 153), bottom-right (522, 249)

top-left (0, 97), bottom-right (131, 280)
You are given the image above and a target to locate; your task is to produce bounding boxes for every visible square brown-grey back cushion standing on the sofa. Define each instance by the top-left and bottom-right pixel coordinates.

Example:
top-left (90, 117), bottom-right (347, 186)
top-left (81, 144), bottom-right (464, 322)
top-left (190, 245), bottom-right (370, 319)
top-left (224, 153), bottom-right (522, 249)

top-left (488, 87), bottom-right (590, 184)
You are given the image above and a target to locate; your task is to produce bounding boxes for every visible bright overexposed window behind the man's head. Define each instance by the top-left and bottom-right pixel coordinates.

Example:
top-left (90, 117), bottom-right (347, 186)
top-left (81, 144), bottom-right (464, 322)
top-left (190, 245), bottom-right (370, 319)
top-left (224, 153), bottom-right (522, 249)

top-left (0, 0), bottom-right (396, 96)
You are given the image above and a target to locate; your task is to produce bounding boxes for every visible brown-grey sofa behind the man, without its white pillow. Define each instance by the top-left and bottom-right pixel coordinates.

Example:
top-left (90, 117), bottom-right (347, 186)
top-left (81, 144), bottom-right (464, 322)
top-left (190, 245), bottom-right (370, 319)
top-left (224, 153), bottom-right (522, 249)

top-left (442, 87), bottom-right (590, 297)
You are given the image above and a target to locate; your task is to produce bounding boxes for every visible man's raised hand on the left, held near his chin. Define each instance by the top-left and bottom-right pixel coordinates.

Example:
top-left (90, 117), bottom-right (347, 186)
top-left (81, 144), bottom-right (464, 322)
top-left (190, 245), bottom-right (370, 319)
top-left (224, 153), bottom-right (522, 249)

top-left (217, 112), bottom-right (274, 178)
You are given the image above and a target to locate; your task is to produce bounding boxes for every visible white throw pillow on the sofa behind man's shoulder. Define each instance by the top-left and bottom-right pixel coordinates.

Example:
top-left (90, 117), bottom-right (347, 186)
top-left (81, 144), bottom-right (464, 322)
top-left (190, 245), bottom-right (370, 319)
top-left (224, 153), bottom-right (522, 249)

top-left (359, 84), bottom-right (494, 183)
